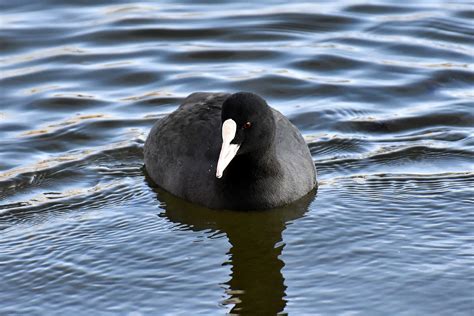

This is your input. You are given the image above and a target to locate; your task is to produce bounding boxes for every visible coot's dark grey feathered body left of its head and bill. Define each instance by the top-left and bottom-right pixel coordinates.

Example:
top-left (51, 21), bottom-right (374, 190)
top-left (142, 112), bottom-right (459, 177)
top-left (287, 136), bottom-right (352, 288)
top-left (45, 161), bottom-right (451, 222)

top-left (145, 93), bottom-right (228, 204)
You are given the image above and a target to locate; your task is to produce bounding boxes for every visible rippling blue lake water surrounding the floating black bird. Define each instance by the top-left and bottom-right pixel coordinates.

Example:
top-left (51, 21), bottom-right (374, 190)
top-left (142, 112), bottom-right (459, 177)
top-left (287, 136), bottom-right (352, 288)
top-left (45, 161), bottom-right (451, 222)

top-left (0, 0), bottom-right (474, 316)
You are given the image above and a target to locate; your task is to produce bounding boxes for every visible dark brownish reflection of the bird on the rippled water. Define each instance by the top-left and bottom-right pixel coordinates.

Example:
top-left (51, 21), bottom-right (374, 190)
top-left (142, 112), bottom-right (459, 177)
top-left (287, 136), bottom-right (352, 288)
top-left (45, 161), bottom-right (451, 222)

top-left (149, 179), bottom-right (316, 315)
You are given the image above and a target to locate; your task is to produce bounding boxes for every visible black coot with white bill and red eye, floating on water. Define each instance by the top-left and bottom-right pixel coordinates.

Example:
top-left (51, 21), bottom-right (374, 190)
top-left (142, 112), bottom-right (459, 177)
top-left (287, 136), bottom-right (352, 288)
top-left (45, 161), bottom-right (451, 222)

top-left (145, 92), bottom-right (317, 210)
